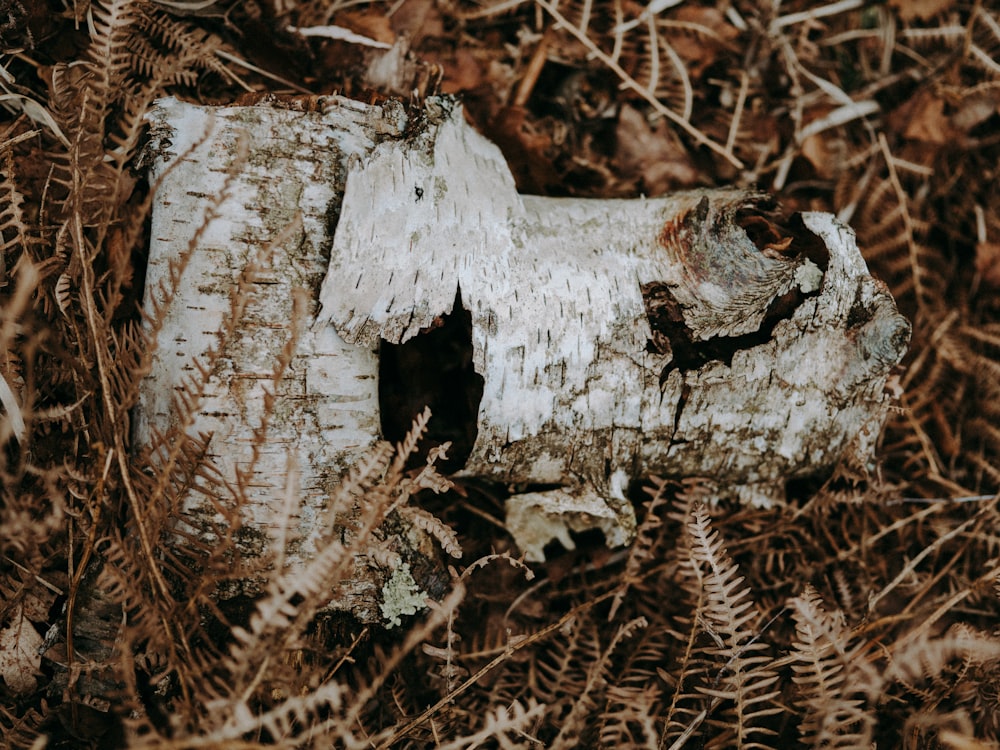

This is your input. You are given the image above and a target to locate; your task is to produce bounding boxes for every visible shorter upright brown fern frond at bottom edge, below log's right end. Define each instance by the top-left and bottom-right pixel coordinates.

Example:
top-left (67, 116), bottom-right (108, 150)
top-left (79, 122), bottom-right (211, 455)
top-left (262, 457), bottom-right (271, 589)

top-left (790, 586), bottom-right (881, 748)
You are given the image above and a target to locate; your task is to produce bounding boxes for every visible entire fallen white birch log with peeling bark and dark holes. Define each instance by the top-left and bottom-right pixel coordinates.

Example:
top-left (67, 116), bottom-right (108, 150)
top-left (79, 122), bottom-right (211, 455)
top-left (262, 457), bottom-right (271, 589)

top-left (140, 97), bottom-right (909, 588)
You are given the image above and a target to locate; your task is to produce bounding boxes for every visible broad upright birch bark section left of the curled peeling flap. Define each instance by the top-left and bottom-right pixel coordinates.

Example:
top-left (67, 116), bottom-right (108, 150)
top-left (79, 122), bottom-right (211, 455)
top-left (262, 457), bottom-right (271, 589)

top-left (135, 99), bottom-right (394, 600)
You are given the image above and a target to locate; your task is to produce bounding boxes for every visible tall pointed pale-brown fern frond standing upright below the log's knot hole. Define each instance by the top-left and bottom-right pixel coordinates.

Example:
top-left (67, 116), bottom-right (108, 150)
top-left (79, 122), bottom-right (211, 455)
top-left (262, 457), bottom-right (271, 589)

top-left (688, 504), bottom-right (781, 748)
